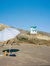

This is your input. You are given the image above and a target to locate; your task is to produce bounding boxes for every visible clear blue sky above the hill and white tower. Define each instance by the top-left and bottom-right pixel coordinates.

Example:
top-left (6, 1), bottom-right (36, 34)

top-left (0, 0), bottom-right (50, 33)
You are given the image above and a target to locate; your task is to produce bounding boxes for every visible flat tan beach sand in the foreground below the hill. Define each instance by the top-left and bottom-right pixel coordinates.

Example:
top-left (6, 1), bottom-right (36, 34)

top-left (0, 44), bottom-right (50, 66)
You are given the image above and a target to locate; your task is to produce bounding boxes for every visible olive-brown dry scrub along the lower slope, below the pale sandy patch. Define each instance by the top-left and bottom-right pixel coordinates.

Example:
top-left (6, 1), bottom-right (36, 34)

top-left (3, 31), bottom-right (50, 45)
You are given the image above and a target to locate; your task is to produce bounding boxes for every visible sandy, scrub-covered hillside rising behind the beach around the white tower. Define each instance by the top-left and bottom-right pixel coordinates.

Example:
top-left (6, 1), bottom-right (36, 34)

top-left (0, 24), bottom-right (50, 45)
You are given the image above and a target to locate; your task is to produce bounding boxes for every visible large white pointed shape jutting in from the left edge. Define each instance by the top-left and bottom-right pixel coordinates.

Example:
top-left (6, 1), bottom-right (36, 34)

top-left (0, 28), bottom-right (20, 41)
